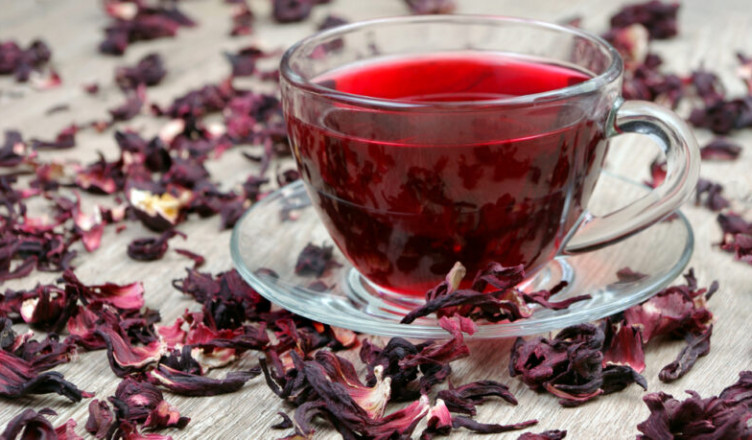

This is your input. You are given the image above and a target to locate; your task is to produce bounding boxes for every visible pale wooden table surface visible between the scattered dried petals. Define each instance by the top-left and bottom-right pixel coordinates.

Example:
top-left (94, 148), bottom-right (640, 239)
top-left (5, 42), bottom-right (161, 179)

top-left (0, 0), bottom-right (752, 439)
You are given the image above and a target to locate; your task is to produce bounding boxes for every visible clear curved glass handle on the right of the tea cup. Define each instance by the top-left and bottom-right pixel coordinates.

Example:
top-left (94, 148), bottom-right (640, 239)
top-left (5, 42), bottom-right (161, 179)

top-left (563, 99), bottom-right (700, 254)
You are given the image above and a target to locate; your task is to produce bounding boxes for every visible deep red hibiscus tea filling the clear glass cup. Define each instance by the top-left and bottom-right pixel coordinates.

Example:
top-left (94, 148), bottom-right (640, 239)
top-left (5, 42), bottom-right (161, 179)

top-left (288, 54), bottom-right (605, 295)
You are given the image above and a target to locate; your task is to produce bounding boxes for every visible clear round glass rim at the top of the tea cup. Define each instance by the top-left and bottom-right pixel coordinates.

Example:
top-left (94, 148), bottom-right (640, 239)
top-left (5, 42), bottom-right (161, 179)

top-left (279, 14), bottom-right (623, 110)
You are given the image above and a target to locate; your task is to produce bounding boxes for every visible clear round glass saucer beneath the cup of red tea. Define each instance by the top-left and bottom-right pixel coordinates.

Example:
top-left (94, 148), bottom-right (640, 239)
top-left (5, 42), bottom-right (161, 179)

top-left (230, 172), bottom-right (694, 339)
